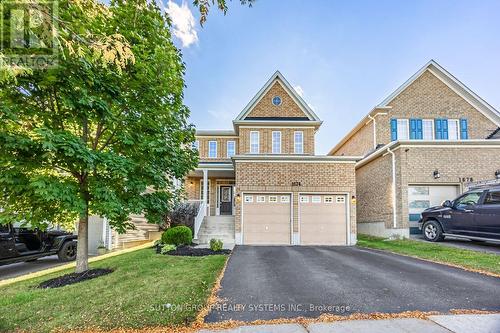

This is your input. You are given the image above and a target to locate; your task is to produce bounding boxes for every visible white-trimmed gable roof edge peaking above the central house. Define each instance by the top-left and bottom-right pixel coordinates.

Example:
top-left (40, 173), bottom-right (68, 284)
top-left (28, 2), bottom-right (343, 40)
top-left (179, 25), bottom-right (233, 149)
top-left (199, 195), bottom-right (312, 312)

top-left (233, 71), bottom-right (321, 123)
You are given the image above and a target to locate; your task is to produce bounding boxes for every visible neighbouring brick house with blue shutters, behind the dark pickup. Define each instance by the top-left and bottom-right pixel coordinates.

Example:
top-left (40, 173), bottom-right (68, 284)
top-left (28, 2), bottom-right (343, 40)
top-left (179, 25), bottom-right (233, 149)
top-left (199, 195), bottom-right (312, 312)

top-left (329, 61), bottom-right (500, 237)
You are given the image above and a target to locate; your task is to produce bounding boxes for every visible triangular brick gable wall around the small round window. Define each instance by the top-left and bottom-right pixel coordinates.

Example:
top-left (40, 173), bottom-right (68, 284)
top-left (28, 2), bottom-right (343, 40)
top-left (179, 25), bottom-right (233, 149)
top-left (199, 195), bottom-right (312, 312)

top-left (247, 81), bottom-right (307, 117)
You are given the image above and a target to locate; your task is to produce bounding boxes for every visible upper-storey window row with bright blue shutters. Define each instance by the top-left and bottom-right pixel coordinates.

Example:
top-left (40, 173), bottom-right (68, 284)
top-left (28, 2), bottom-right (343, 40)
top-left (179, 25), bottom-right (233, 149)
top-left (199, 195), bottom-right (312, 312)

top-left (391, 119), bottom-right (469, 141)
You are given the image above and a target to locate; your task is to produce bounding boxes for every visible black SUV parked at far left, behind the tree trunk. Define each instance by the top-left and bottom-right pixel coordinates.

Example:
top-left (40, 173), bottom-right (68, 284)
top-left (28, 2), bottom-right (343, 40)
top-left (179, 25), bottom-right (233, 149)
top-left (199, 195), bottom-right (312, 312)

top-left (0, 224), bottom-right (77, 266)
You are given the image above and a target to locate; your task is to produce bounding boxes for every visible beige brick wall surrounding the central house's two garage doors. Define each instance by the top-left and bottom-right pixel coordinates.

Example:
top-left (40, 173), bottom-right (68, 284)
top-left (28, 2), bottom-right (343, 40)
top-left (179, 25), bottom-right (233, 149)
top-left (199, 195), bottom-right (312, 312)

top-left (235, 161), bottom-right (356, 234)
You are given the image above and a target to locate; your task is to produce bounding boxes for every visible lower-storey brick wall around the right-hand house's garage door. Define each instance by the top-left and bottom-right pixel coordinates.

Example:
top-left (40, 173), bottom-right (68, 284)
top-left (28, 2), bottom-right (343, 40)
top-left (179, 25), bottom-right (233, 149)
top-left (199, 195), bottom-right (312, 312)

top-left (356, 147), bottom-right (500, 228)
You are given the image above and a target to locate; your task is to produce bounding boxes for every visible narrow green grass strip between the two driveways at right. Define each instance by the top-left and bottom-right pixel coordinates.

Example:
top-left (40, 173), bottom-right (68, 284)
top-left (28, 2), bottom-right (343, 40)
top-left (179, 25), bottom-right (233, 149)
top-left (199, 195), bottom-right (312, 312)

top-left (358, 235), bottom-right (500, 274)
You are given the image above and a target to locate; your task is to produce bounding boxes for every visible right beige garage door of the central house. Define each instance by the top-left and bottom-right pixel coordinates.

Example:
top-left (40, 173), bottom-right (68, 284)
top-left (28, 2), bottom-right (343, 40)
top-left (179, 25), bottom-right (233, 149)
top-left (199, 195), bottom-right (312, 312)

top-left (299, 194), bottom-right (347, 245)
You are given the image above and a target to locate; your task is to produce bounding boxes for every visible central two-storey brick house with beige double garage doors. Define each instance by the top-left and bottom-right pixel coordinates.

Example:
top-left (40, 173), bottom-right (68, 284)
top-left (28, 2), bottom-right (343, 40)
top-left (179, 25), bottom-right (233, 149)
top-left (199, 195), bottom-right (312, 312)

top-left (185, 72), bottom-right (358, 245)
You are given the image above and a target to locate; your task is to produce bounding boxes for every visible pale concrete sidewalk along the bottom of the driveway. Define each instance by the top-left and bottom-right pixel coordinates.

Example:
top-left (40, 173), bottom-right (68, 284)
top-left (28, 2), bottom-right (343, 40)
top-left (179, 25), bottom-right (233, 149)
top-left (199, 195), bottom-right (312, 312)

top-left (198, 314), bottom-right (500, 333)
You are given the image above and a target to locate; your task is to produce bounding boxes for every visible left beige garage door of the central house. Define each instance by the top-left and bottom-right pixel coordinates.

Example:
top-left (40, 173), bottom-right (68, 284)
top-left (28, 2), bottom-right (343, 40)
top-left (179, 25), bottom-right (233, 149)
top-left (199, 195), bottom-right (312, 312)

top-left (242, 193), bottom-right (291, 245)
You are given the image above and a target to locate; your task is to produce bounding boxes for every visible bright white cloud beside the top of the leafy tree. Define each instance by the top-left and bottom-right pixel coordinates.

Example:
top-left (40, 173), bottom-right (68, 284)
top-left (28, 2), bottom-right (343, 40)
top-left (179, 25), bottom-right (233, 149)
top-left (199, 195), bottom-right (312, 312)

top-left (165, 0), bottom-right (198, 47)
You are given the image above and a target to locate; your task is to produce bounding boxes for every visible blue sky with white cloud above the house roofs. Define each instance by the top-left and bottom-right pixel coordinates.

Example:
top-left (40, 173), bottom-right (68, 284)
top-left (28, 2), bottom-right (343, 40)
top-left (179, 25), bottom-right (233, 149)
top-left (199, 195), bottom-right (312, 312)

top-left (164, 0), bottom-right (500, 154)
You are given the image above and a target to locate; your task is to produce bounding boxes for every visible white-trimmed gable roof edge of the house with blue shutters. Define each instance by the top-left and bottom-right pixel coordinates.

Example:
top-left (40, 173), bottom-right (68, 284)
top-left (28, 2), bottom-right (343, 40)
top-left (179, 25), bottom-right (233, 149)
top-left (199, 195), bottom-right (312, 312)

top-left (328, 59), bottom-right (500, 155)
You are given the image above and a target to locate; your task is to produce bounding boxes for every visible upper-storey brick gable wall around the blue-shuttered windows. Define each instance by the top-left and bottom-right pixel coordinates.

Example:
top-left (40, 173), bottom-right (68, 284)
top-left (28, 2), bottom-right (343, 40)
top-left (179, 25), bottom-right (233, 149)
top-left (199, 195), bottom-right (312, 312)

top-left (377, 71), bottom-right (497, 144)
